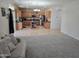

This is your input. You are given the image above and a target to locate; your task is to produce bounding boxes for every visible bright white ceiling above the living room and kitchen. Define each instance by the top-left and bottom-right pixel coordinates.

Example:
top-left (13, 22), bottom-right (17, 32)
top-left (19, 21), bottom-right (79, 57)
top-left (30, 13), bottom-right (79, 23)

top-left (15, 0), bottom-right (75, 8)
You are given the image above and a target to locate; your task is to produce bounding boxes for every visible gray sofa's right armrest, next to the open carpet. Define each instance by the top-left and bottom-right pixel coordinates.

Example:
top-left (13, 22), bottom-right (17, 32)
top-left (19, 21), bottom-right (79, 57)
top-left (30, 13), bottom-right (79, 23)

top-left (11, 40), bottom-right (26, 58)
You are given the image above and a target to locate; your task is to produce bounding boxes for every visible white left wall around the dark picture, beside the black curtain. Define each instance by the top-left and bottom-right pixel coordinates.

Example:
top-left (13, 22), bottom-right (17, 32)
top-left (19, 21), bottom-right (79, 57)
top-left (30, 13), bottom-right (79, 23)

top-left (0, 0), bottom-right (13, 36)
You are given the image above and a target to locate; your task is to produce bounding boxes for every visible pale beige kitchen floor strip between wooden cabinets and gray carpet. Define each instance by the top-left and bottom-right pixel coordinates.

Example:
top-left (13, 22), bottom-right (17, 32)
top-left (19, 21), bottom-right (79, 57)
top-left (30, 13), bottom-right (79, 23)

top-left (14, 27), bottom-right (51, 37)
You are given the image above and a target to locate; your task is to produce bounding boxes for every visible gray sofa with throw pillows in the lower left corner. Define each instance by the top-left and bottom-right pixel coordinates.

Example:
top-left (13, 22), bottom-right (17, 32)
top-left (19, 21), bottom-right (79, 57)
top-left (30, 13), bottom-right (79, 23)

top-left (0, 34), bottom-right (26, 58)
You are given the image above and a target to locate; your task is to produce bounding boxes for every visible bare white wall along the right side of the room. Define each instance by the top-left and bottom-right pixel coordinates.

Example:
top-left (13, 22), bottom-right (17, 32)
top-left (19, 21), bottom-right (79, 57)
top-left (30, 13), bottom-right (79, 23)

top-left (61, 0), bottom-right (79, 39)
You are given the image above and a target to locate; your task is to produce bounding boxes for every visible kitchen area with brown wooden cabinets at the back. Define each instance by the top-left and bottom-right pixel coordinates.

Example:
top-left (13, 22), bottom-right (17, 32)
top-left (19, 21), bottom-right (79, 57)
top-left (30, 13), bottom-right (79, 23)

top-left (15, 7), bottom-right (51, 30)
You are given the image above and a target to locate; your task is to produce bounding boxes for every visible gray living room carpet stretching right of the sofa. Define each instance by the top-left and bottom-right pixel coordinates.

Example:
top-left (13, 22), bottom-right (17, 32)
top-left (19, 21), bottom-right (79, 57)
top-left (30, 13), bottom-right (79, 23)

top-left (14, 28), bottom-right (79, 58)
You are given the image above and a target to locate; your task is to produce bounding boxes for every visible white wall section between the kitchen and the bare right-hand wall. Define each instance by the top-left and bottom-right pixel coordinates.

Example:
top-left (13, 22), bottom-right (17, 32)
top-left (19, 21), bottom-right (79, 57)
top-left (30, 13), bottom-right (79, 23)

top-left (51, 7), bottom-right (61, 31)
